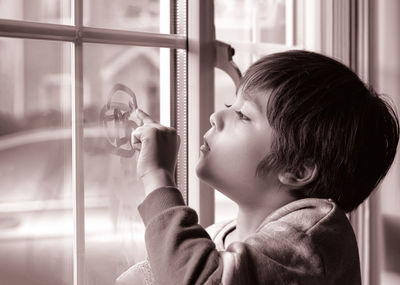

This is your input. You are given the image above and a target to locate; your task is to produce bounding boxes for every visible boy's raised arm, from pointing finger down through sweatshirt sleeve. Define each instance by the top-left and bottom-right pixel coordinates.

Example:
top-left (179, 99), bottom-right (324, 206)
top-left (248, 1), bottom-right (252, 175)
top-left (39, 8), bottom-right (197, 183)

top-left (131, 109), bottom-right (227, 285)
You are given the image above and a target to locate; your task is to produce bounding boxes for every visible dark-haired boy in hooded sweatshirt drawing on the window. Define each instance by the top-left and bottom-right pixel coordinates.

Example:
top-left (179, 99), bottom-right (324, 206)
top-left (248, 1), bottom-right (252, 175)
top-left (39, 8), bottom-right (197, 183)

top-left (118, 51), bottom-right (399, 284)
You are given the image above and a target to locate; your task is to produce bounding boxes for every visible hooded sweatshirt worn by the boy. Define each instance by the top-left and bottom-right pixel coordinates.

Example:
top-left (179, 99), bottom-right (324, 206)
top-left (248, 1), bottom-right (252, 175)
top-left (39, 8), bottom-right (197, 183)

top-left (117, 187), bottom-right (361, 285)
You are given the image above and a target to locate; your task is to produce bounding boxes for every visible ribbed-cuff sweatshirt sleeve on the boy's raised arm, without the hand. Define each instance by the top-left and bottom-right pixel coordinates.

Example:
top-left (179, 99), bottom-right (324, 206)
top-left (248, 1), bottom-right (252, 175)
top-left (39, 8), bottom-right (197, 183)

top-left (139, 187), bottom-right (222, 284)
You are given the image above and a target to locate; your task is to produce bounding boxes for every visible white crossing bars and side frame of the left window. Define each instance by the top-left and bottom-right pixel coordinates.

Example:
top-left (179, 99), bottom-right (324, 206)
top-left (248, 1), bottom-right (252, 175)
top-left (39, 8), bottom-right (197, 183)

top-left (0, 0), bottom-right (188, 285)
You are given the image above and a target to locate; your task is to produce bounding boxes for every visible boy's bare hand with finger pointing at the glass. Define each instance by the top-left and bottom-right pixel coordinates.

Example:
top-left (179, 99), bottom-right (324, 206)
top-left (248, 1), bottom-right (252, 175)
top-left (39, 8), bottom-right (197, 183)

top-left (131, 109), bottom-right (180, 194)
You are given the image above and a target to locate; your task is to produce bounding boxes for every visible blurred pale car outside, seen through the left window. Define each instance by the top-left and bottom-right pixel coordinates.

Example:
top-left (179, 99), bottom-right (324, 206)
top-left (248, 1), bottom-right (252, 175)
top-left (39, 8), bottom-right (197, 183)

top-left (0, 124), bottom-right (145, 285)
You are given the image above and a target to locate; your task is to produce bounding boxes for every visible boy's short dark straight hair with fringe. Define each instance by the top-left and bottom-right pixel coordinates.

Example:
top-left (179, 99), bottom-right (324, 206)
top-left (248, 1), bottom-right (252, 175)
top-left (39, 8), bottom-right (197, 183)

top-left (241, 50), bottom-right (399, 212)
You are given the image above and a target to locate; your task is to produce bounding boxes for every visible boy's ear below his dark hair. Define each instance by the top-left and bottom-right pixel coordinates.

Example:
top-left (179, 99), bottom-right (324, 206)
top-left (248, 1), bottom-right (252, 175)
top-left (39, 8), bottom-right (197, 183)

top-left (278, 164), bottom-right (318, 188)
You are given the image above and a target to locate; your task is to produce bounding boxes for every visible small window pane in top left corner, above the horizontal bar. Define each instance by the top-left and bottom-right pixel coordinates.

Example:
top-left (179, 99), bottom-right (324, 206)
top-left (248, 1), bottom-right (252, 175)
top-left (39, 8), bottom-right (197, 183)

top-left (0, 0), bottom-right (71, 25)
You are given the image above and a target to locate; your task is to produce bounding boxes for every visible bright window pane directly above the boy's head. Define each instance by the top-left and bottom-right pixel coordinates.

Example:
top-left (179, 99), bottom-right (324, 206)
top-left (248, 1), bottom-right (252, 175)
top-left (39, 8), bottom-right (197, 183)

top-left (215, 0), bottom-right (286, 44)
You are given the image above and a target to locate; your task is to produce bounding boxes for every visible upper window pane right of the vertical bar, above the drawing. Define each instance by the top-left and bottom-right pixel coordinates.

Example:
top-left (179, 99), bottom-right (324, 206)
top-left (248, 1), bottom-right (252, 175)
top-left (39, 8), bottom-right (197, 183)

top-left (83, 0), bottom-right (162, 33)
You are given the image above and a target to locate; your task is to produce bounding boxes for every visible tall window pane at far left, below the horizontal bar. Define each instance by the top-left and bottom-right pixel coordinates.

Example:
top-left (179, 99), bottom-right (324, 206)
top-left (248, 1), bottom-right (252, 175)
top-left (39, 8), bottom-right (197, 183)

top-left (0, 38), bottom-right (73, 285)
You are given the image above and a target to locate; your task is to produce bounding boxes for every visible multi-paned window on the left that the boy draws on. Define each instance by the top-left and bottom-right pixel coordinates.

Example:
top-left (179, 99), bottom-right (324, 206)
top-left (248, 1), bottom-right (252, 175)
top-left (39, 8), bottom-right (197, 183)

top-left (0, 0), bottom-right (187, 285)
